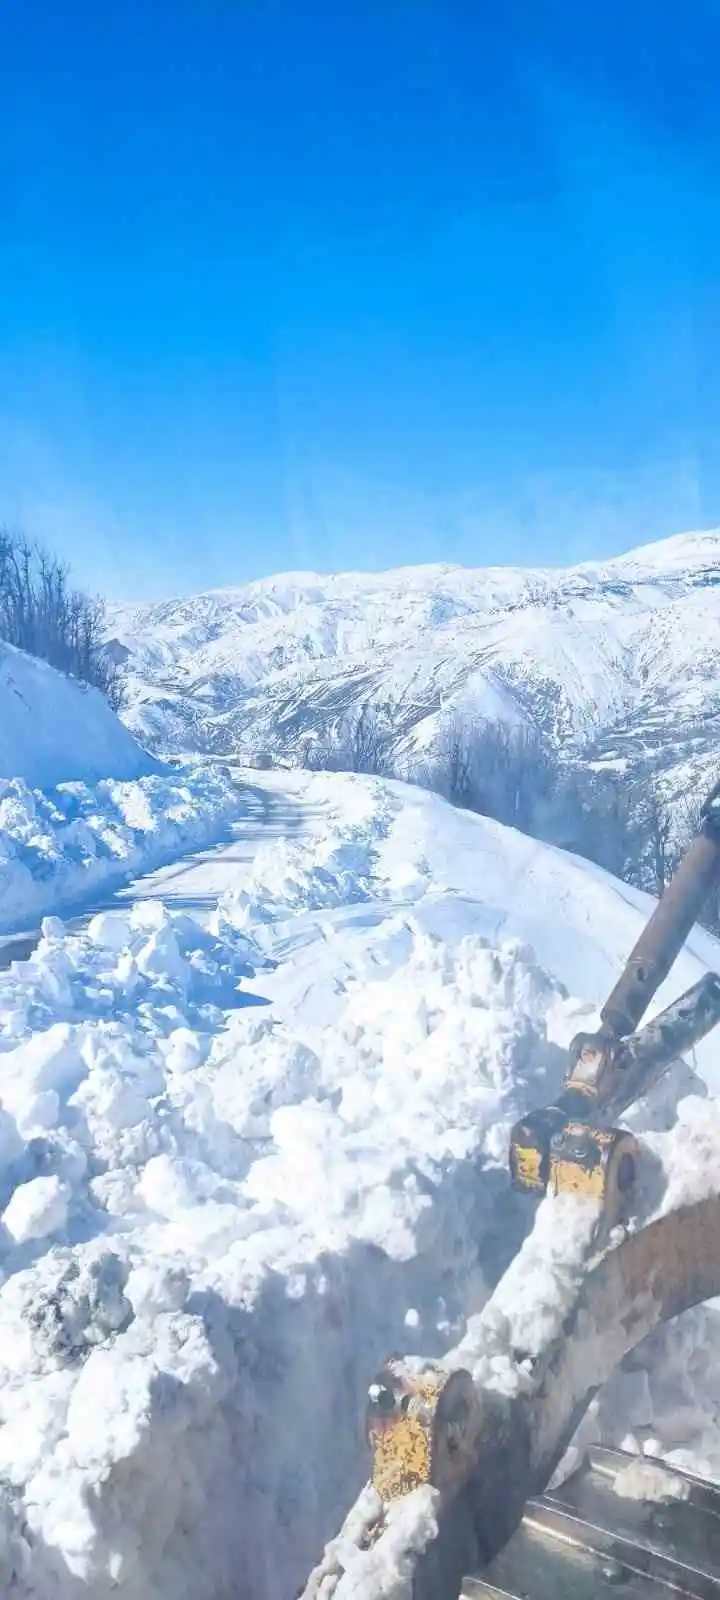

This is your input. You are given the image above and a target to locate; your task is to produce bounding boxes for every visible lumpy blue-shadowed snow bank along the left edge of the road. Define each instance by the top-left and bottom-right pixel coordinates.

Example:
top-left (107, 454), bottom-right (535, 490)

top-left (0, 765), bottom-right (251, 933)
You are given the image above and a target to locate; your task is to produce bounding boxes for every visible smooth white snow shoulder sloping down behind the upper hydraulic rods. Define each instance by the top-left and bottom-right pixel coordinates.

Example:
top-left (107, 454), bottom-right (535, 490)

top-left (368, 779), bottom-right (720, 1036)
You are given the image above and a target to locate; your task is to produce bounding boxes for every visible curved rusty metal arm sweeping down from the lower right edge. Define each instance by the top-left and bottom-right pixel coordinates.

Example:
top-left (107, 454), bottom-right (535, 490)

top-left (301, 1195), bottom-right (720, 1600)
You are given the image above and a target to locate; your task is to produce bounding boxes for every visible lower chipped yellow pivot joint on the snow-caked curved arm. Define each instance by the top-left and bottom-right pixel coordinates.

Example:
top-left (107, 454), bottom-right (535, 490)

top-left (366, 1358), bottom-right (480, 1504)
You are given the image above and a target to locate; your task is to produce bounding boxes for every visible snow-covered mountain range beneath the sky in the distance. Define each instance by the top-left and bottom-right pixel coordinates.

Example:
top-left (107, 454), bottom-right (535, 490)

top-left (109, 531), bottom-right (720, 793)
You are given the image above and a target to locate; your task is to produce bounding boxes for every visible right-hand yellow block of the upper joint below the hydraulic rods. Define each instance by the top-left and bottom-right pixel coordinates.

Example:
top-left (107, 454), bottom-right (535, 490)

top-left (550, 1122), bottom-right (638, 1227)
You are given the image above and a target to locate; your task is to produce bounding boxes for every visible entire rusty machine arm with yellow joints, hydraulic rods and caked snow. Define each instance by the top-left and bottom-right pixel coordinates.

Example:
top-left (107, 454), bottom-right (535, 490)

top-left (301, 784), bottom-right (720, 1600)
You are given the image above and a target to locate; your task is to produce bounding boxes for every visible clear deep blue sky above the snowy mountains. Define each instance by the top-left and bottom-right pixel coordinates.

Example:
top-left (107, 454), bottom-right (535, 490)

top-left (0, 0), bottom-right (720, 598)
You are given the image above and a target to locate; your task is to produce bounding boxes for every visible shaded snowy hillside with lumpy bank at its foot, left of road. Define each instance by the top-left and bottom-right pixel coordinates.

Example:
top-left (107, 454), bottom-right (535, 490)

top-left (0, 642), bottom-right (268, 934)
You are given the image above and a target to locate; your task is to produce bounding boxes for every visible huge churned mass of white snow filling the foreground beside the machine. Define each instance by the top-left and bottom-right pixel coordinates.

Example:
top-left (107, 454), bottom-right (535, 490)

top-left (0, 774), bottom-right (720, 1600)
